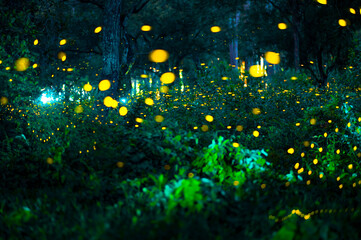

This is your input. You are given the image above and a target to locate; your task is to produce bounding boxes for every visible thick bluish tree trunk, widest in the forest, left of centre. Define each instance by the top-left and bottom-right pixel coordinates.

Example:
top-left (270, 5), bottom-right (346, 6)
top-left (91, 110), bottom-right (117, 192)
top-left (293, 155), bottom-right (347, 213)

top-left (100, 0), bottom-right (122, 104)
